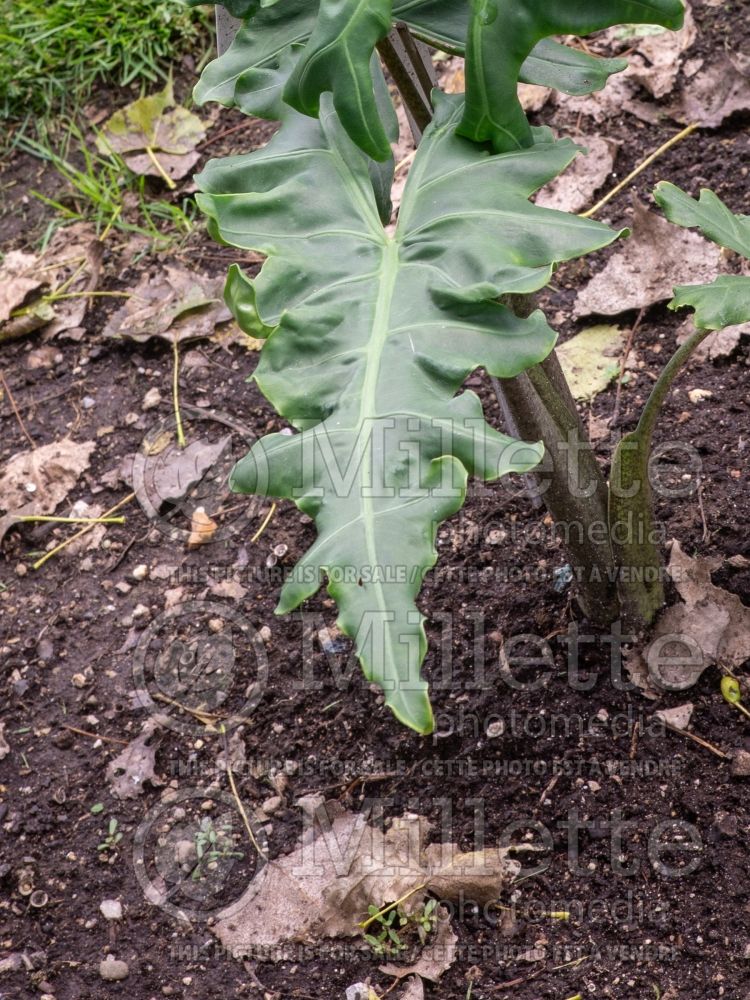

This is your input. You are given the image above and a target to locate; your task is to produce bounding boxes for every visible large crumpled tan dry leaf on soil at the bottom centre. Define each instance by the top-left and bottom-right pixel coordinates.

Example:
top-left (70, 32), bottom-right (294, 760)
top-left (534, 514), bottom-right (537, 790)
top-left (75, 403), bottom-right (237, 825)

top-left (213, 803), bottom-right (518, 959)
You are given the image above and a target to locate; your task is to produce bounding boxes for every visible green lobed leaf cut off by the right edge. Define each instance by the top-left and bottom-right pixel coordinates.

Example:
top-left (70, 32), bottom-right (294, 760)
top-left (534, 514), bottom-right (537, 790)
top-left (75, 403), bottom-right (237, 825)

top-left (654, 181), bottom-right (750, 330)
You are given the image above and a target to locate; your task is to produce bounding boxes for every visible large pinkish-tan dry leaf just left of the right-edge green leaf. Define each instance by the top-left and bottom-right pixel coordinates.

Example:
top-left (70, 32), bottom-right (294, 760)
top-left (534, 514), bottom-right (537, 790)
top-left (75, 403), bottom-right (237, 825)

top-left (574, 199), bottom-right (722, 317)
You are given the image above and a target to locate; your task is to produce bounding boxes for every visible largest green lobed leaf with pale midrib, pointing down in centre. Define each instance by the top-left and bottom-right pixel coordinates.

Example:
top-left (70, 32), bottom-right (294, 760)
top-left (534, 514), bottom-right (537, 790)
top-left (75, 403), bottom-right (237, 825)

top-left (197, 84), bottom-right (616, 732)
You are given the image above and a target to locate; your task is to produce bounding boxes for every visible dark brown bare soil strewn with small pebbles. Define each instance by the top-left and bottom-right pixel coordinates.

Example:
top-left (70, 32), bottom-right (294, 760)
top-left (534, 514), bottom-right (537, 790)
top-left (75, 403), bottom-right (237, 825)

top-left (0, 4), bottom-right (750, 1000)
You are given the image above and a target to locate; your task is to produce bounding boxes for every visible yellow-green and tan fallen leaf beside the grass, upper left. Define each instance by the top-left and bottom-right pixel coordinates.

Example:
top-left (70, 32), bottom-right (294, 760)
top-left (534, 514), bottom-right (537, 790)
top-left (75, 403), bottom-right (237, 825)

top-left (96, 81), bottom-right (206, 180)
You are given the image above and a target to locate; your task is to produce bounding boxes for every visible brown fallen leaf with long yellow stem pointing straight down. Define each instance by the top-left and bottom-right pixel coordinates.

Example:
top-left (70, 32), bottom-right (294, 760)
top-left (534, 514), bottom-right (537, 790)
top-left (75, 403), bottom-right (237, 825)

top-left (104, 265), bottom-right (231, 344)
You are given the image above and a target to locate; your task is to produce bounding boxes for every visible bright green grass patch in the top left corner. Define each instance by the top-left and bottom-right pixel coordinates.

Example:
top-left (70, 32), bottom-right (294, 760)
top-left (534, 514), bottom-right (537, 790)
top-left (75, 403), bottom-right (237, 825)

top-left (0, 0), bottom-right (209, 120)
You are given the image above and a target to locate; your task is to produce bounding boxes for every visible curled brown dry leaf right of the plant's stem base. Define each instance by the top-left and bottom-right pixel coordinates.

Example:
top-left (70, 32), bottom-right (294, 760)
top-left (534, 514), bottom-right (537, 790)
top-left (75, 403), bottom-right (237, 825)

top-left (627, 541), bottom-right (750, 698)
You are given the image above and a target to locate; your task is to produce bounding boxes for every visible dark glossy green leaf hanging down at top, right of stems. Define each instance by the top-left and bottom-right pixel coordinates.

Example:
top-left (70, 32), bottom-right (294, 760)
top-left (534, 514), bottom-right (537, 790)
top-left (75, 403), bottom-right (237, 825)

top-left (459, 0), bottom-right (684, 152)
